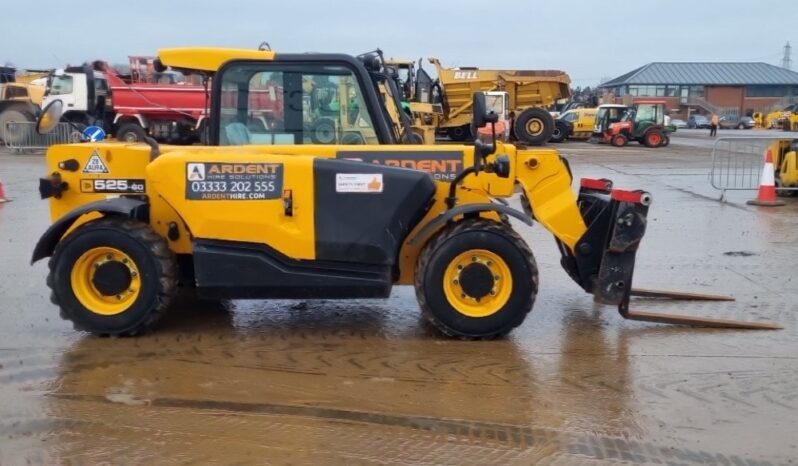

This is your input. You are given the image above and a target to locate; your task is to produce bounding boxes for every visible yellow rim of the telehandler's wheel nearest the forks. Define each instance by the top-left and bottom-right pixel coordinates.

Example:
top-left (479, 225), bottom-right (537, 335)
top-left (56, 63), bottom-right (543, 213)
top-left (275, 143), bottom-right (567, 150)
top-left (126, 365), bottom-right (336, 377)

top-left (443, 249), bottom-right (513, 317)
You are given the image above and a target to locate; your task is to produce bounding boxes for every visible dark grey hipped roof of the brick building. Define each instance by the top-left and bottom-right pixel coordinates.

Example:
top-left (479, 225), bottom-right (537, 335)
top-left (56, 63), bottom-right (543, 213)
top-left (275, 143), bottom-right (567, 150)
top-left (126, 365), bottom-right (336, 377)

top-left (599, 62), bottom-right (798, 87)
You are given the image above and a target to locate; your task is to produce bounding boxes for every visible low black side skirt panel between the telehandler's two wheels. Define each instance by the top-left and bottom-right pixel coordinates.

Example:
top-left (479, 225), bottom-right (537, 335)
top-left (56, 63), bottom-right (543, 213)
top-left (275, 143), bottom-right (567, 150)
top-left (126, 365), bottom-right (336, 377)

top-left (194, 239), bottom-right (392, 299)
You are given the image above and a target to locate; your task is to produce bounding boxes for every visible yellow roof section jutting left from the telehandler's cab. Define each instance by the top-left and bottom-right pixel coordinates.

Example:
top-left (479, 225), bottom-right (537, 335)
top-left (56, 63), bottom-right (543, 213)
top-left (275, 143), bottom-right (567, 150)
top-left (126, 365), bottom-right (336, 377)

top-left (158, 47), bottom-right (275, 71)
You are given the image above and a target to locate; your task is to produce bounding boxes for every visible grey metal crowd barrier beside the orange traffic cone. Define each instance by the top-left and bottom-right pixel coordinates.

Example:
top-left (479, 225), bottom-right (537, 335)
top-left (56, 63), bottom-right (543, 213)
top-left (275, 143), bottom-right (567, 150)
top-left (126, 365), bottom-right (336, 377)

top-left (709, 136), bottom-right (798, 197)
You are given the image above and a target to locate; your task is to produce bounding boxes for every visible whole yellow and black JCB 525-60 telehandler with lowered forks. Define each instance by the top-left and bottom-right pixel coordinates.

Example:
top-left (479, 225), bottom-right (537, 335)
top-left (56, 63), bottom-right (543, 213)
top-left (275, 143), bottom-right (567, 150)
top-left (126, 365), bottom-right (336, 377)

top-left (32, 48), bottom-right (780, 339)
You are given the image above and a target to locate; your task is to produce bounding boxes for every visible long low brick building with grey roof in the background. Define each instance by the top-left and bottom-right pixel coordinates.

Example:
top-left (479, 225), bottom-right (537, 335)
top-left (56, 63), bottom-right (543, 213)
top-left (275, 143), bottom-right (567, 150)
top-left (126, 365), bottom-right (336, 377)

top-left (599, 62), bottom-right (798, 119)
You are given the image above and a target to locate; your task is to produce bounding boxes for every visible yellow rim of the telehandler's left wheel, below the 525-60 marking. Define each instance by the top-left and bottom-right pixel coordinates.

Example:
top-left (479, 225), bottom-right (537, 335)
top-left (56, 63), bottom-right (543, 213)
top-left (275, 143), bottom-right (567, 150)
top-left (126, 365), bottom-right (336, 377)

top-left (71, 247), bottom-right (141, 316)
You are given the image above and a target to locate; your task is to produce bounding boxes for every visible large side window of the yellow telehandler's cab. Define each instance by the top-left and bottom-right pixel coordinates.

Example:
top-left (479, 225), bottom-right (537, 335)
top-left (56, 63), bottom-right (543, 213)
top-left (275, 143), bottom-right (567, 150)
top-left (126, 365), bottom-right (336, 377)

top-left (219, 63), bottom-right (379, 145)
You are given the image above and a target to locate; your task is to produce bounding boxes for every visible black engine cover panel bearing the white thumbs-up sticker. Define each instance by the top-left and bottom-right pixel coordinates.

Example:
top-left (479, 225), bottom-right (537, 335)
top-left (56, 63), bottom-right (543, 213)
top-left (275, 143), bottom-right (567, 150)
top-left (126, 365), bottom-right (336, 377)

top-left (313, 158), bottom-right (435, 265)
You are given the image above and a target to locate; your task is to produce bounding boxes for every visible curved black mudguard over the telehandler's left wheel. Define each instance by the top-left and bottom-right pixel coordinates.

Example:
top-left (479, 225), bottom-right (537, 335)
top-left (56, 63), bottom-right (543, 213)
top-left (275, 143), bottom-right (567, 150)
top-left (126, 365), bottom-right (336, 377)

top-left (31, 197), bottom-right (148, 264)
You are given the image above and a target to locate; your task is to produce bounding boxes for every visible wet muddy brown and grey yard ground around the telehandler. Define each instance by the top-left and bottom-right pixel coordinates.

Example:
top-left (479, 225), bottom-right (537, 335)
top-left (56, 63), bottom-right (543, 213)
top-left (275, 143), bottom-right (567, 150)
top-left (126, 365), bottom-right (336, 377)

top-left (0, 131), bottom-right (798, 465)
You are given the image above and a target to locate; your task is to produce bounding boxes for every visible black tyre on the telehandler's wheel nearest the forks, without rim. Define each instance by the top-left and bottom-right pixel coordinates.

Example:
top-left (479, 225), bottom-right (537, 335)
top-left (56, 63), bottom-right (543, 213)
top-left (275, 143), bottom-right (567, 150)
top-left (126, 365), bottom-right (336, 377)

top-left (415, 219), bottom-right (538, 340)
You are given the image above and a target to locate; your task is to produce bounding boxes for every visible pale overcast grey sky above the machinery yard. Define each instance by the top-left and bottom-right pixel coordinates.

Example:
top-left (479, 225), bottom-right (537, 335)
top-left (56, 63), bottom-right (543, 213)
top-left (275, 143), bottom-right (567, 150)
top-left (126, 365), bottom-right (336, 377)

top-left (0, 0), bottom-right (798, 86)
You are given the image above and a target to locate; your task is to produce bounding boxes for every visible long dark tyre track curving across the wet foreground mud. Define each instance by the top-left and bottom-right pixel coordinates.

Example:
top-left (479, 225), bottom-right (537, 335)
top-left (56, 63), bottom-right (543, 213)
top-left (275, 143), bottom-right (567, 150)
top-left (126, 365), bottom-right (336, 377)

top-left (25, 394), bottom-right (774, 466)
